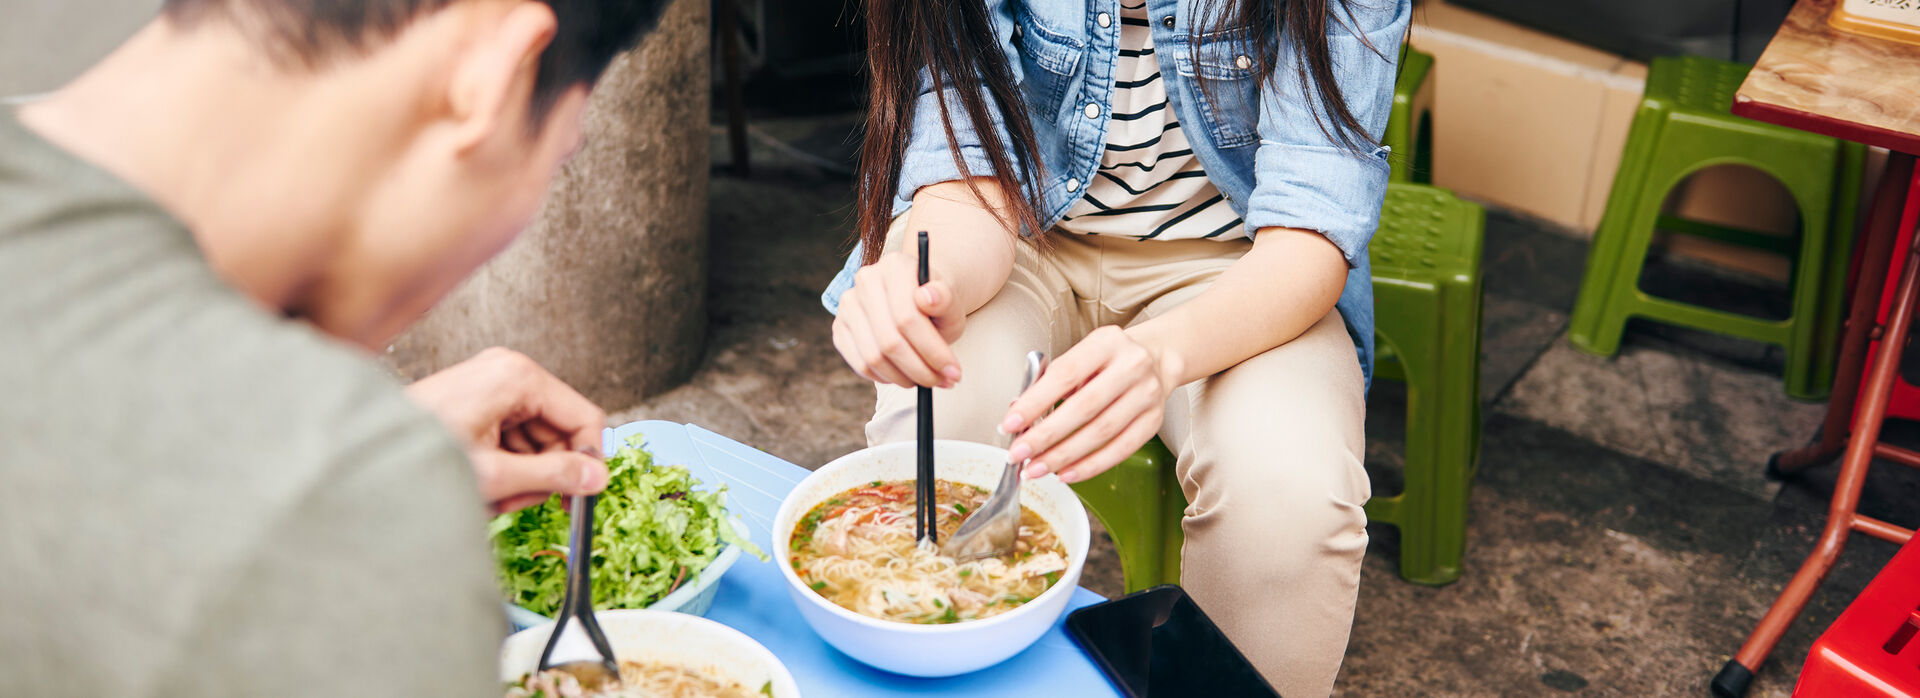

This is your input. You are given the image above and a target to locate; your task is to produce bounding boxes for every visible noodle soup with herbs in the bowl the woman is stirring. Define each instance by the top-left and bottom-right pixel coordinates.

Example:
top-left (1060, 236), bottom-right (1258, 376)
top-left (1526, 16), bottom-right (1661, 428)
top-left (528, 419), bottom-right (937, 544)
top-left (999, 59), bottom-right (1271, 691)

top-left (789, 479), bottom-right (1068, 623)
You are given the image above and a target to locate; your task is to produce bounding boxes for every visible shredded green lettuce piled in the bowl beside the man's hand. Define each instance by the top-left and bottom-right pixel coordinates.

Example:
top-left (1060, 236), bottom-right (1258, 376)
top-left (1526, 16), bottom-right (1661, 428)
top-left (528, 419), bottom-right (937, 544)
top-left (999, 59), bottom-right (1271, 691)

top-left (490, 435), bottom-right (766, 616)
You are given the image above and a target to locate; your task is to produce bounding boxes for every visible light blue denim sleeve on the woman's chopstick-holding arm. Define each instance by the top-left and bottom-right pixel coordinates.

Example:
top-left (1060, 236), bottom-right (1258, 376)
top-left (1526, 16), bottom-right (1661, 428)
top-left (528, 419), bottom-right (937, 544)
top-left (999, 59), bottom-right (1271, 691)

top-left (893, 0), bottom-right (1023, 215)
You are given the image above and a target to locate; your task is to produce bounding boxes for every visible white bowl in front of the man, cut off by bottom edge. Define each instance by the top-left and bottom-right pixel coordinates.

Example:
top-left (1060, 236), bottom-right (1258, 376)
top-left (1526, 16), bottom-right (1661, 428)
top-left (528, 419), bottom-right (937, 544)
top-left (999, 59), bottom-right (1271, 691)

top-left (499, 610), bottom-right (801, 698)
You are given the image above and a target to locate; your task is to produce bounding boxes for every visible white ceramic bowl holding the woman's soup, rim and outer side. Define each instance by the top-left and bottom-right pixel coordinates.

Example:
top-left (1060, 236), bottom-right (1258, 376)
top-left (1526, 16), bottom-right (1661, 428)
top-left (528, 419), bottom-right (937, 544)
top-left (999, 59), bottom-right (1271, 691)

top-left (772, 441), bottom-right (1089, 677)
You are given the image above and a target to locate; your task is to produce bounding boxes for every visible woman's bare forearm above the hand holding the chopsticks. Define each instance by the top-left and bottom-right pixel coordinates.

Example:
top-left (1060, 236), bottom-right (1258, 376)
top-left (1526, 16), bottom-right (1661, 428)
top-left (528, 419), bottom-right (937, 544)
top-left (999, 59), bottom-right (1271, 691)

top-left (900, 176), bottom-right (1018, 314)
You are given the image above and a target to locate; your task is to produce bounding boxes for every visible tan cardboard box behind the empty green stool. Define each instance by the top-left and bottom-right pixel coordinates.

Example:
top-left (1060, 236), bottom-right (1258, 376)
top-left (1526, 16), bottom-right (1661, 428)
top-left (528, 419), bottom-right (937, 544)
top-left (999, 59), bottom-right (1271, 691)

top-left (1409, 0), bottom-right (1797, 280)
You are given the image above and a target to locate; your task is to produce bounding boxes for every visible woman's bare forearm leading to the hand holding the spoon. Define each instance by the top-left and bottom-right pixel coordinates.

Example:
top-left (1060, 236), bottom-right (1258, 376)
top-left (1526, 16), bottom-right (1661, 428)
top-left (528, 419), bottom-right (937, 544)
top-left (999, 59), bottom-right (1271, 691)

top-left (1127, 228), bottom-right (1348, 385)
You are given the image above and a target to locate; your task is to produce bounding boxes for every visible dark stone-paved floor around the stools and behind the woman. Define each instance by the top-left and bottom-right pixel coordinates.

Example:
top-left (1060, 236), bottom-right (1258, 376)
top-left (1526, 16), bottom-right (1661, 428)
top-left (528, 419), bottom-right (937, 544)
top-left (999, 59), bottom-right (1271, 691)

top-left (616, 115), bottom-right (1920, 696)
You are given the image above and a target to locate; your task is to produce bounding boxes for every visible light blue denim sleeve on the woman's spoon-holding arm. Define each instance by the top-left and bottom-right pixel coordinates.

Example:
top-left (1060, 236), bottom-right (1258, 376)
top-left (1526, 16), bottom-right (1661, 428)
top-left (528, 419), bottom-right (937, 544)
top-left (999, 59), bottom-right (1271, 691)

top-left (1246, 0), bottom-right (1413, 267)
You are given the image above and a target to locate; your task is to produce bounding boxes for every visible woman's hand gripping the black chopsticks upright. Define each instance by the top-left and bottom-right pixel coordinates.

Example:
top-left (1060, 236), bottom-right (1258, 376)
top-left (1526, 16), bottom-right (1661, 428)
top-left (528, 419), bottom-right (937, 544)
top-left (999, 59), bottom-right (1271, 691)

top-left (833, 251), bottom-right (966, 387)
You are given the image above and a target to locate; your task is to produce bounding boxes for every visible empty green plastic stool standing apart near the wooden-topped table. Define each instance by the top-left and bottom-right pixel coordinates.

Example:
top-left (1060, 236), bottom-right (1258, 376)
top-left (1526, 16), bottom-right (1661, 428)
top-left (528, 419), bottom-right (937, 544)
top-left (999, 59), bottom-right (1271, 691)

top-left (1567, 56), bottom-right (1862, 399)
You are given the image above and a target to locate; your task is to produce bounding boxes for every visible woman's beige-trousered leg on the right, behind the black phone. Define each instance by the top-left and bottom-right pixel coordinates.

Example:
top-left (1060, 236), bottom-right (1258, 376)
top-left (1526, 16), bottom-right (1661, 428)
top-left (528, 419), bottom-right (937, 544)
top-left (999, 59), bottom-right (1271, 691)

top-left (1136, 293), bottom-right (1371, 696)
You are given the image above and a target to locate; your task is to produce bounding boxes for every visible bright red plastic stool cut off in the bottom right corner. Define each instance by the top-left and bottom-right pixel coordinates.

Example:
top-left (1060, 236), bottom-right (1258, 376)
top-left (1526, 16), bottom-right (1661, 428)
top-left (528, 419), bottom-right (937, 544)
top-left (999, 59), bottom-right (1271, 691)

top-left (1793, 539), bottom-right (1920, 698)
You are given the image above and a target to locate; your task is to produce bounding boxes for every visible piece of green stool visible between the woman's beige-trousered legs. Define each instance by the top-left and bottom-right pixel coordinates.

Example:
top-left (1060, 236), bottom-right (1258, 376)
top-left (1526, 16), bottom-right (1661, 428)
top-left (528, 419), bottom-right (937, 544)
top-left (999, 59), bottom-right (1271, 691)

top-left (1073, 437), bottom-right (1187, 593)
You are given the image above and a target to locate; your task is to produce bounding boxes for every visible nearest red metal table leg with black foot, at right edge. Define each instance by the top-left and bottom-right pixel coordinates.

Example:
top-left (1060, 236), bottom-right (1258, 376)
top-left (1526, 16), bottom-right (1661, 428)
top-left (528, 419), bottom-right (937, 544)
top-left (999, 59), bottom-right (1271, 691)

top-left (1713, 159), bottom-right (1920, 698)
